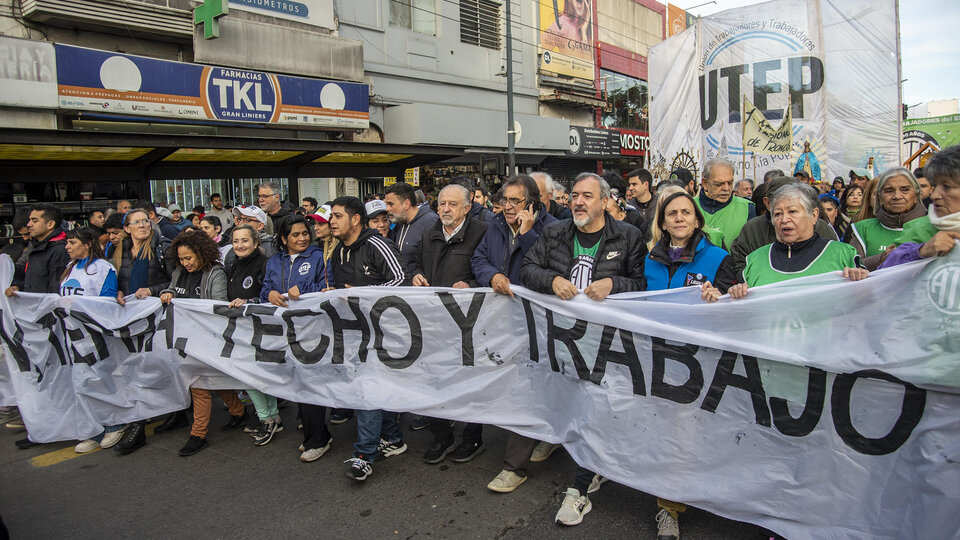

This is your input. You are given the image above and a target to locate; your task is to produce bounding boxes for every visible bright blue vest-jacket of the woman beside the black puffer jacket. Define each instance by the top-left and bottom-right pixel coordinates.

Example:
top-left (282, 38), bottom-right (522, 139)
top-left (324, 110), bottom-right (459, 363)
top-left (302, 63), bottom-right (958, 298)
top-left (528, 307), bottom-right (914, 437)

top-left (643, 233), bottom-right (735, 293)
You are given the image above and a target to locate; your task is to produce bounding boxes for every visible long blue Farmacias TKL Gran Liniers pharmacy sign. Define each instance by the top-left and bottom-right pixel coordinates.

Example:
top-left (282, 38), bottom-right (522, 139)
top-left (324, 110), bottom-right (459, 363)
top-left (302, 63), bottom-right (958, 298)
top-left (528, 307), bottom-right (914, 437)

top-left (56, 44), bottom-right (370, 129)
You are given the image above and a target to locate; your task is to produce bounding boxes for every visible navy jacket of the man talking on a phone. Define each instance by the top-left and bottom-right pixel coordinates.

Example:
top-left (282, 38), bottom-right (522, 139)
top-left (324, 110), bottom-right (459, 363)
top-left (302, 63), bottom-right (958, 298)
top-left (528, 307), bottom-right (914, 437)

top-left (470, 206), bottom-right (557, 287)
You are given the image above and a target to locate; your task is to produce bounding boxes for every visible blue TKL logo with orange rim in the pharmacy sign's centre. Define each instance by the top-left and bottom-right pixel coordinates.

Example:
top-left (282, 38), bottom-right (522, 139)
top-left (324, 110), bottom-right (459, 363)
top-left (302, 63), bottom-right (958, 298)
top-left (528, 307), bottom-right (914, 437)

top-left (201, 67), bottom-right (279, 122)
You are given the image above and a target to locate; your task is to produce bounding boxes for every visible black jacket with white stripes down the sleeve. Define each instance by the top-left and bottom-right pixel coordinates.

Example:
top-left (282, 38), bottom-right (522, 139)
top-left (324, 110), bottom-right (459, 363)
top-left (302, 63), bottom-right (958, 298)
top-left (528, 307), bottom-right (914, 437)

top-left (330, 228), bottom-right (411, 289)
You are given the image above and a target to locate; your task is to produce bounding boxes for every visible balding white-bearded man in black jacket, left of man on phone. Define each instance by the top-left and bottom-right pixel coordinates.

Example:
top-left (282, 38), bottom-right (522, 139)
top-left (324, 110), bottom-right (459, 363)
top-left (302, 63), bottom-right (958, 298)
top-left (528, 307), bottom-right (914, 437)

top-left (413, 184), bottom-right (487, 465)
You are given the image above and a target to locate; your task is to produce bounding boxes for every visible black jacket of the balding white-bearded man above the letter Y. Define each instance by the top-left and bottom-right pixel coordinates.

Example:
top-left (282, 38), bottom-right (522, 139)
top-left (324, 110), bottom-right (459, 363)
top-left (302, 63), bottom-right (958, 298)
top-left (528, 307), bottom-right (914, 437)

top-left (413, 216), bottom-right (487, 287)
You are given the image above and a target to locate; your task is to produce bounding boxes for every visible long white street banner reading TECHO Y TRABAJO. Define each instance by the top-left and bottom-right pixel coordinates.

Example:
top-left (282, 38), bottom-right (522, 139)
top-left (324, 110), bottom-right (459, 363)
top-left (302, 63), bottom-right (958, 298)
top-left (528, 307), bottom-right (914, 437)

top-left (0, 249), bottom-right (960, 539)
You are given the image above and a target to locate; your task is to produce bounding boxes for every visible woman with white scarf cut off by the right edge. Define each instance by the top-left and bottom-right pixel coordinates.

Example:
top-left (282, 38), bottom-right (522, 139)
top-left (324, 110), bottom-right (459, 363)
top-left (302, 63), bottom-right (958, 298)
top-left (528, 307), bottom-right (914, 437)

top-left (881, 145), bottom-right (960, 268)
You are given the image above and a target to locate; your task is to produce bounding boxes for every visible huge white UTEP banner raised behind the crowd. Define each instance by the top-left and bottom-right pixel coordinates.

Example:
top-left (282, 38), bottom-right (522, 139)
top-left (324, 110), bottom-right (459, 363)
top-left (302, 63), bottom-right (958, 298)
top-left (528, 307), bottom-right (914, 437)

top-left (650, 0), bottom-right (900, 181)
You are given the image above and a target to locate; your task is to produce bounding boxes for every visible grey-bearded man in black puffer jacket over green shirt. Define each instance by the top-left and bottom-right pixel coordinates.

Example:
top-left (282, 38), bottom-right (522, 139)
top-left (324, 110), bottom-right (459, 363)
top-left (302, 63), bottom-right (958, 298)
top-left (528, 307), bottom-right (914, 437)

top-left (520, 173), bottom-right (647, 525)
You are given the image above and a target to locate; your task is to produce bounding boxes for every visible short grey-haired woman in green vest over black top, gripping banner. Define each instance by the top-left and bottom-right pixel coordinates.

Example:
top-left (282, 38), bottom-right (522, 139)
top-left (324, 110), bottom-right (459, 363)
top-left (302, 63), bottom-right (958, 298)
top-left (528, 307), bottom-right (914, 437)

top-left (720, 184), bottom-right (869, 299)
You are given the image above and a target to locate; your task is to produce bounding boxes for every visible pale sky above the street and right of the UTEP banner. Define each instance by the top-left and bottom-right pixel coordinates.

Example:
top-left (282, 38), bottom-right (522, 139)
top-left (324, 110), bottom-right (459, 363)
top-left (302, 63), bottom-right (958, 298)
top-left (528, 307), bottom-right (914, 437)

top-left (671, 0), bottom-right (960, 105)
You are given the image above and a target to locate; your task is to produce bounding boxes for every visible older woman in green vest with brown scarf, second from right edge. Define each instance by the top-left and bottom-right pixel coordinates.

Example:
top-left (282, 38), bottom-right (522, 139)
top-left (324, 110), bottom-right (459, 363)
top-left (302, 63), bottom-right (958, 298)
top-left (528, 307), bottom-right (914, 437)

top-left (847, 167), bottom-right (927, 270)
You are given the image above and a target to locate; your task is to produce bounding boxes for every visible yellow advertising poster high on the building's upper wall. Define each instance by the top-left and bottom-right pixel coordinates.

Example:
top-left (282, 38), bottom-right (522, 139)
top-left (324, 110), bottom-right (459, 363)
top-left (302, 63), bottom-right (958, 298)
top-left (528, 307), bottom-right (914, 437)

top-left (537, 0), bottom-right (594, 81)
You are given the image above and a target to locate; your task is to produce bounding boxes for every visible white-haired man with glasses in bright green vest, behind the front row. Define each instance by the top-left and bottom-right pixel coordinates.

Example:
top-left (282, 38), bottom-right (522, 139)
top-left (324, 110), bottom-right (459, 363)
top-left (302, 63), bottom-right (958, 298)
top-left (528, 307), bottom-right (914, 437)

top-left (695, 157), bottom-right (757, 251)
